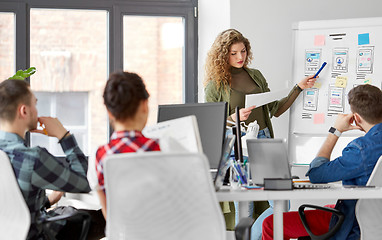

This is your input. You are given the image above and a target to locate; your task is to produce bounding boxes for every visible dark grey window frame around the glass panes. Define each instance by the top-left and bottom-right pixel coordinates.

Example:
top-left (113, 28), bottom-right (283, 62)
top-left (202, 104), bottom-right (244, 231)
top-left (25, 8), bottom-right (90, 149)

top-left (0, 0), bottom-right (198, 150)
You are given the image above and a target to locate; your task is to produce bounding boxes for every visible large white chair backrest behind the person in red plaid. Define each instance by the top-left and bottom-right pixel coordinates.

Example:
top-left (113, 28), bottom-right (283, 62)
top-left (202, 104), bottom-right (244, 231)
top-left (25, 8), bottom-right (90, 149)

top-left (104, 152), bottom-right (226, 240)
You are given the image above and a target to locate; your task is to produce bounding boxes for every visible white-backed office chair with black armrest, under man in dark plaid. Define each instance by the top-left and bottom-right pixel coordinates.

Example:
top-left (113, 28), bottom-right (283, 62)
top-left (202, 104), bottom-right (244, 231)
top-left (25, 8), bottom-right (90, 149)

top-left (0, 150), bottom-right (91, 240)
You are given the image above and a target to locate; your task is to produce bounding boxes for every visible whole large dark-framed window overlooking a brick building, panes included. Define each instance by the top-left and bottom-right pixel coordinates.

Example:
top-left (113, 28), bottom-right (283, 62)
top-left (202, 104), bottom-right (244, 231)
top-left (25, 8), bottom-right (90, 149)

top-left (0, 0), bottom-right (198, 156)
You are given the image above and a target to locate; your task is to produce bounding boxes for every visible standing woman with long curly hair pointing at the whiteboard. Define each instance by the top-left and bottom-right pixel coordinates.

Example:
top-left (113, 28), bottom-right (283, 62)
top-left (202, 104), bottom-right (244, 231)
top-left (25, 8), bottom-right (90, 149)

top-left (204, 29), bottom-right (316, 240)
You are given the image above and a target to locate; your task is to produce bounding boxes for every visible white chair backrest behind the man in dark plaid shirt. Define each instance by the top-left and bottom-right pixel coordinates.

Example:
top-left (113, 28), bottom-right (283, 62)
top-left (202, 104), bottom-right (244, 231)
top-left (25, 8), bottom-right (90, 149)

top-left (0, 151), bottom-right (31, 240)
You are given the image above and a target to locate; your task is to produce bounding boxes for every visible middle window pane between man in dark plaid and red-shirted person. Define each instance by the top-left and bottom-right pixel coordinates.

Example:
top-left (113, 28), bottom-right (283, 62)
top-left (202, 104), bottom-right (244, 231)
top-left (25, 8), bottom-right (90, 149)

top-left (30, 9), bottom-right (108, 155)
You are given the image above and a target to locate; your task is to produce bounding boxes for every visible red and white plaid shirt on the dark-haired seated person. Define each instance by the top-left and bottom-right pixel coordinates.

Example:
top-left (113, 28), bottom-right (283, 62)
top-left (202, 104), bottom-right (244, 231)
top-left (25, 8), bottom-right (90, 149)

top-left (96, 131), bottom-right (160, 192)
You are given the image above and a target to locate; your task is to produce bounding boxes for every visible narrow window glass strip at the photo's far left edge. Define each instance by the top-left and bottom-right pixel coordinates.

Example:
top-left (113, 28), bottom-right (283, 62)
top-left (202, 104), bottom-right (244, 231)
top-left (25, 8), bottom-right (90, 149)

top-left (0, 12), bottom-right (16, 82)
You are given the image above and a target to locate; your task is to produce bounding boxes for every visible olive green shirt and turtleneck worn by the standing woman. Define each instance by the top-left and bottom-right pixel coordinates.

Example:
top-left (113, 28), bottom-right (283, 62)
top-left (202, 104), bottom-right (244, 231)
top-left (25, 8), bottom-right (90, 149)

top-left (204, 68), bottom-right (301, 138)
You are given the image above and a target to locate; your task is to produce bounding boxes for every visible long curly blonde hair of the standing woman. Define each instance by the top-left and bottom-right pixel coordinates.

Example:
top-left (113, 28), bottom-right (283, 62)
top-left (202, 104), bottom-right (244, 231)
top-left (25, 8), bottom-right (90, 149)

top-left (204, 29), bottom-right (252, 88)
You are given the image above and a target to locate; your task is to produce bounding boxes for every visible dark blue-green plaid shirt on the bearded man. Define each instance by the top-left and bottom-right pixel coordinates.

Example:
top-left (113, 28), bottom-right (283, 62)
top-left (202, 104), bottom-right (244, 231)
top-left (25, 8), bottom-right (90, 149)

top-left (0, 131), bottom-right (90, 239)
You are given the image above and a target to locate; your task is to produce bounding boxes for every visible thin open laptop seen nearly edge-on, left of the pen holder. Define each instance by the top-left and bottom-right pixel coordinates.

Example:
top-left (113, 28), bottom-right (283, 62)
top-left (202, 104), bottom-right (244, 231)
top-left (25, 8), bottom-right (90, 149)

top-left (214, 135), bottom-right (235, 191)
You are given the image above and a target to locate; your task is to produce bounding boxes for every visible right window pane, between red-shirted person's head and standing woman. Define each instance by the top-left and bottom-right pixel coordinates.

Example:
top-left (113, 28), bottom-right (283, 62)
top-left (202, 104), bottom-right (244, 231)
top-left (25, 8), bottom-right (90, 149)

top-left (123, 16), bottom-right (185, 125)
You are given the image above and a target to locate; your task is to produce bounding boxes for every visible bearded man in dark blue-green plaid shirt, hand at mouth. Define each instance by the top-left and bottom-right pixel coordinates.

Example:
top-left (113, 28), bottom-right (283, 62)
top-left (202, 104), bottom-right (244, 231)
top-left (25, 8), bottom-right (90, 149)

top-left (0, 80), bottom-right (90, 239)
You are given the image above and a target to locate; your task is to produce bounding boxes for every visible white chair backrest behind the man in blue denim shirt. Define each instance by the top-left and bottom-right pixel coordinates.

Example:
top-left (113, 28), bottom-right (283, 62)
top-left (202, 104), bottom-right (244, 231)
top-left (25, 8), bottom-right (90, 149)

top-left (355, 156), bottom-right (382, 240)
